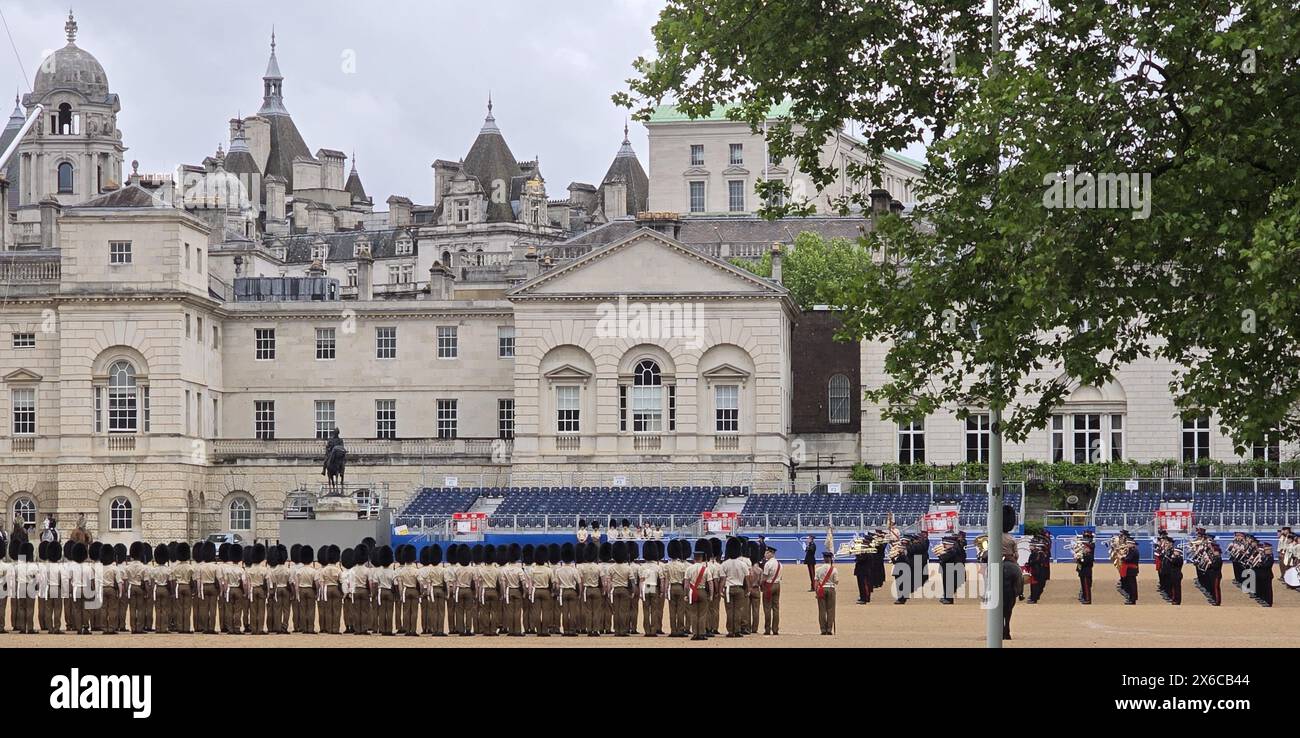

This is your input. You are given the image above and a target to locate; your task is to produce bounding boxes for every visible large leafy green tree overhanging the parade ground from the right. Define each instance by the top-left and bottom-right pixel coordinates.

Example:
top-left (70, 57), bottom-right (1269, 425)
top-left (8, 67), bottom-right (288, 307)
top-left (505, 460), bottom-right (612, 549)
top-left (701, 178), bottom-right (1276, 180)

top-left (615, 0), bottom-right (1300, 447)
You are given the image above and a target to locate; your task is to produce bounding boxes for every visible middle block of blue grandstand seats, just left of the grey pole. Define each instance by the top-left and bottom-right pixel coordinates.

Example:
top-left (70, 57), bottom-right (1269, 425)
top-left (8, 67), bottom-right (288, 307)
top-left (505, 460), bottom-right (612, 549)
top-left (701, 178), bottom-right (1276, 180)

top-left (738, 492), bottom-right (1021, 528)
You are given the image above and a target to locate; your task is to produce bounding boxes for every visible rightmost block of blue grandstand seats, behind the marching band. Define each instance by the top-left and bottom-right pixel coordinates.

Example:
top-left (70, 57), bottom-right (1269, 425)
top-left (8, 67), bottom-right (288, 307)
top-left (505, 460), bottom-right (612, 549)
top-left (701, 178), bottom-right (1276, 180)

top-left (1093, 481), bottom-right (1300, 529)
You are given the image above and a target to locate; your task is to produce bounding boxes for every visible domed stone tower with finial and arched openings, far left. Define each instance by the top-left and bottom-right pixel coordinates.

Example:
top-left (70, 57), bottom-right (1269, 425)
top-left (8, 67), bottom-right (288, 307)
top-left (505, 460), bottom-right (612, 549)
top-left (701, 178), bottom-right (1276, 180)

top-left (16, 13), bottom-right (126, 207)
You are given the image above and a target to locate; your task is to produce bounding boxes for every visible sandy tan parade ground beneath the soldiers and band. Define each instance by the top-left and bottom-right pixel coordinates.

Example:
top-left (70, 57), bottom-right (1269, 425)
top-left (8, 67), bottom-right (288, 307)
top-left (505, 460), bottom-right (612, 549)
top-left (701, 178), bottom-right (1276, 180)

top-left (0, 564), bottom-right (1300, 648)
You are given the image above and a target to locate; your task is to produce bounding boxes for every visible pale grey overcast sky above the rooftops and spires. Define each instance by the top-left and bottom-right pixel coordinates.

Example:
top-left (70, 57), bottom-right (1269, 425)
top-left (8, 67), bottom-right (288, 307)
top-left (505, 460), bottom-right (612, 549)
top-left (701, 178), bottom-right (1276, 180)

top-left (0, 0), bottom-right (663, 209)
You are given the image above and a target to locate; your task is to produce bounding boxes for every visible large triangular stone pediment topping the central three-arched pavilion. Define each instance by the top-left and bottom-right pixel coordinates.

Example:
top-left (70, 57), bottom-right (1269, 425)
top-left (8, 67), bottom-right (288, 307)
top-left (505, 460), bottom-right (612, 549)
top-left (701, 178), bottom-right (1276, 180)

top-left (508, 229), bottom-right (787, 300)
